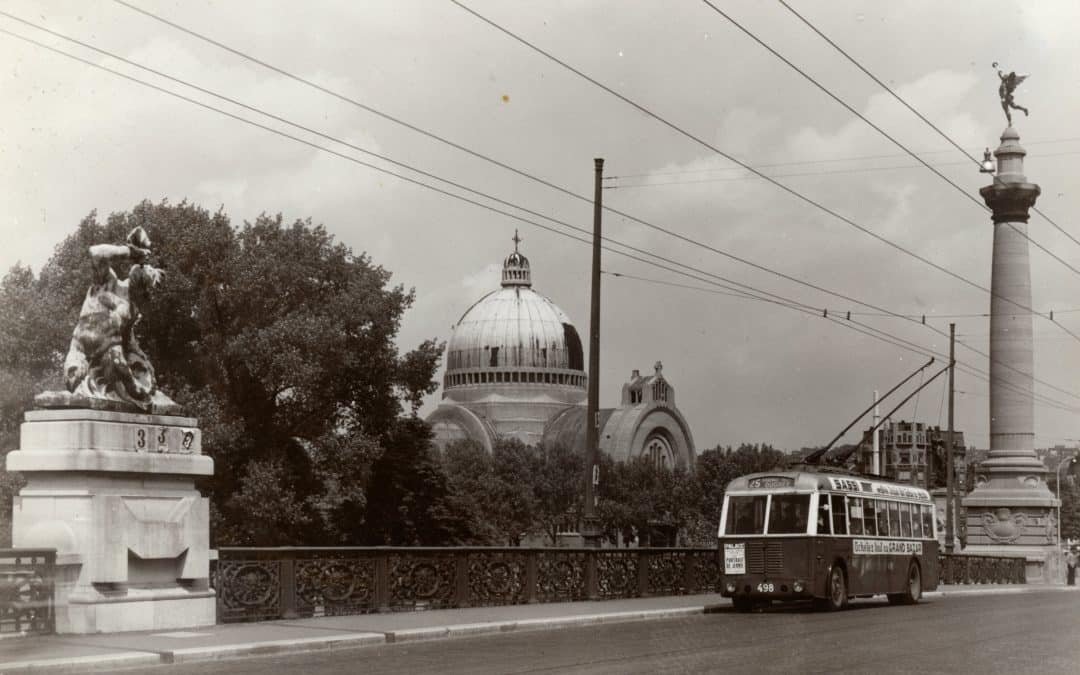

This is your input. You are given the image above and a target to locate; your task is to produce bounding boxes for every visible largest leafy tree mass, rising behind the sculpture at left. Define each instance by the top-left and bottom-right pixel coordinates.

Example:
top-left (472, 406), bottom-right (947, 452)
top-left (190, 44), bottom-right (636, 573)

top-left (0, 202), bottom-right (442, 545)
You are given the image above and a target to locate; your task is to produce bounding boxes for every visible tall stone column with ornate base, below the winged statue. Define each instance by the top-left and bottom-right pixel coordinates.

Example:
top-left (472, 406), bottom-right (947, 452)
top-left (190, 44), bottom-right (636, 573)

top-left (963, 126), bottom-right (1058, 583)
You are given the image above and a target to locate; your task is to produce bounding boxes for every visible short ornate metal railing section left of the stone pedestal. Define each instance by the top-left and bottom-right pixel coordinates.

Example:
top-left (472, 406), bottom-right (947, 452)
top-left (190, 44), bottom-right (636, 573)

top-left (0, 549), bottom-right (56, 634)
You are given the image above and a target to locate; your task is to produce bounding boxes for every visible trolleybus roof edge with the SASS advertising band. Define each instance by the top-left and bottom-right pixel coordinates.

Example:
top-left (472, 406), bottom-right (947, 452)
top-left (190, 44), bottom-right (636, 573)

top-left (727, 471), bottom-right (931, 502)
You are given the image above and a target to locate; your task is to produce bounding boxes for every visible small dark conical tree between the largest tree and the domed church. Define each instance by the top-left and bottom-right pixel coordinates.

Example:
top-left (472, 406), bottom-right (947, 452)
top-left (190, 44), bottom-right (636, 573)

top-left (363, 418), bottom-right (472, 546)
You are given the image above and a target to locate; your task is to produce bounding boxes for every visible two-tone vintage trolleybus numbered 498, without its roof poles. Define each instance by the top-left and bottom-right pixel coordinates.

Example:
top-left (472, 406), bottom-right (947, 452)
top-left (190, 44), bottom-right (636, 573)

top-left (719, 471), bottom-right (937, 611)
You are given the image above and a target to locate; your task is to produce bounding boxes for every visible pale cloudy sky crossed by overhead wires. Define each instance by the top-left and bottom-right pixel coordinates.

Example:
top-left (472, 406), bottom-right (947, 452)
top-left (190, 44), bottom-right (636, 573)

top-left (0, 0), bottom-right (1080, 448)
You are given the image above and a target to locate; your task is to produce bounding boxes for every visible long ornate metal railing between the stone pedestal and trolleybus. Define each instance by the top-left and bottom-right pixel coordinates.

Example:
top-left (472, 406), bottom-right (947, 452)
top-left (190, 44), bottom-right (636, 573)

top-left (211, 548), bottom-right (720, 623)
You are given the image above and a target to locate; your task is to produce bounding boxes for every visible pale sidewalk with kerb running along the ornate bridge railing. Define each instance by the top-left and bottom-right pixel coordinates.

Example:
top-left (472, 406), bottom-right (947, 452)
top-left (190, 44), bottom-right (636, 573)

top-left (0, 585), bottom-right (1080, 675)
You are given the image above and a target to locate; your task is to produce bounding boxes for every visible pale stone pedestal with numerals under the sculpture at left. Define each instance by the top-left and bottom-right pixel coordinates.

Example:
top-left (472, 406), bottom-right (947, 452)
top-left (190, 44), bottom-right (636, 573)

top-left (8, 409), bottom-right (216, 634)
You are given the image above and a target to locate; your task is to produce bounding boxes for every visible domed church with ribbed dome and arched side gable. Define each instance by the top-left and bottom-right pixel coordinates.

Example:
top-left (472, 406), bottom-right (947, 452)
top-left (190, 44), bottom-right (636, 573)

top-left (428, 233), bottom-right (694, 470)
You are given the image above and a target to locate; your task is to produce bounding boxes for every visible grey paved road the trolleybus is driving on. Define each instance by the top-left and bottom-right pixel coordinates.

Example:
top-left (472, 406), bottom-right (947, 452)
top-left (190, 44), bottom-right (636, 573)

top-left (113, 593), bottom-right (1080, 675)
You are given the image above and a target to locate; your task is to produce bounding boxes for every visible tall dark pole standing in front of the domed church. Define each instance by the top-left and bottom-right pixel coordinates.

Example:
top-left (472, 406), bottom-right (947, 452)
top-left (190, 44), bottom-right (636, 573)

top-left (581, 158), bottom-right (604, 549)
